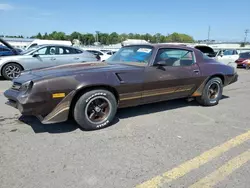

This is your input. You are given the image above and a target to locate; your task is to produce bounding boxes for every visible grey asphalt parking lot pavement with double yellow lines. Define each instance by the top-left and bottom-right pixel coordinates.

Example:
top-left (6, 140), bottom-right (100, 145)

top-left (0, 70), bottom-right (250, 188)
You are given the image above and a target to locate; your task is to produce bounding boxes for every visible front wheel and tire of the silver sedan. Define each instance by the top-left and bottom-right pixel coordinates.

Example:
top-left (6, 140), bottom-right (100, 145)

top-left (2, 63), bottom-right (23, 80)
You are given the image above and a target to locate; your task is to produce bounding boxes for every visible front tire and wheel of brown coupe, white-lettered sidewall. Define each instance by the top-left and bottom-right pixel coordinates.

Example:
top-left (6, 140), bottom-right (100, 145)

top-left (73, 89), bottom-right (117, 131)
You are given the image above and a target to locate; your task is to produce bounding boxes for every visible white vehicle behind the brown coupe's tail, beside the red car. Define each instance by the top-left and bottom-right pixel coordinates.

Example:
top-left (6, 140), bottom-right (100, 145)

top-left (214, 49), bottom-right (239, 68)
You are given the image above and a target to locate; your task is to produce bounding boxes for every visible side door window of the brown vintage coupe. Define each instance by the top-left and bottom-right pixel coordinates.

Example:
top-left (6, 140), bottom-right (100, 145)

top-left (155, 48), bottom-right (194, 66)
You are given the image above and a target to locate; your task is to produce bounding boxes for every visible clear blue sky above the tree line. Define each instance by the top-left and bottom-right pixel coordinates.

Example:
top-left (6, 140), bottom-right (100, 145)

top-left (0, 0), bottom-right (250, 41)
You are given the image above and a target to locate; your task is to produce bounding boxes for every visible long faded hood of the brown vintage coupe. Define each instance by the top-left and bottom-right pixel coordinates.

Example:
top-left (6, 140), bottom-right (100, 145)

top-left (21, 61), bottom-right (144, 77)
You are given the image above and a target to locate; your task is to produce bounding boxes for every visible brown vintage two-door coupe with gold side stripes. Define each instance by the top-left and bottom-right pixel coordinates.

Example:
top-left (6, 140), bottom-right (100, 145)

top-left (4, 44), bottom-right (238, 130)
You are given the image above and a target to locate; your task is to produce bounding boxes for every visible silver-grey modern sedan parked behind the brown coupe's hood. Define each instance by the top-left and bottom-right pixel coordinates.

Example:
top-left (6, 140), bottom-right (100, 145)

top-left (0, 44), bottom-right (97, 80)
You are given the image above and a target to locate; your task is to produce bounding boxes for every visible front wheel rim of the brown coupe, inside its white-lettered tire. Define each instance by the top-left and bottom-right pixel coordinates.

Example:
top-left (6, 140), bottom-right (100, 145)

top-left (85, 96), bottom-right (111, 124)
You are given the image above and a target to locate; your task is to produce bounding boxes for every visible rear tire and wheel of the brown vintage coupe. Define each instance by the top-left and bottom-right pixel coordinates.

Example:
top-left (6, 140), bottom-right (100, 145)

top-left (196, 77), bottom-right (223, 106)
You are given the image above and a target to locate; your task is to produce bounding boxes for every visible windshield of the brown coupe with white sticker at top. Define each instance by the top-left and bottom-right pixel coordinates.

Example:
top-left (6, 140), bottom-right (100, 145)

top-left (106, 45), bottom-right (153, 64)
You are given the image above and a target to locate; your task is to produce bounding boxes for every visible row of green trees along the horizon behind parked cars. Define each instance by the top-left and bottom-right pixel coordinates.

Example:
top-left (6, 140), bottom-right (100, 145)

top-left (0, 31), bottom-right (194, 45)
